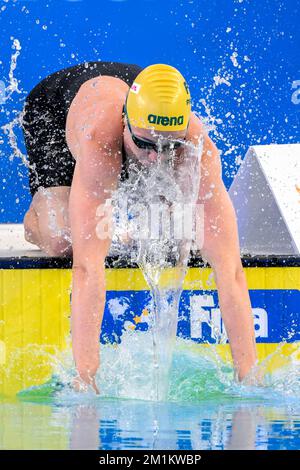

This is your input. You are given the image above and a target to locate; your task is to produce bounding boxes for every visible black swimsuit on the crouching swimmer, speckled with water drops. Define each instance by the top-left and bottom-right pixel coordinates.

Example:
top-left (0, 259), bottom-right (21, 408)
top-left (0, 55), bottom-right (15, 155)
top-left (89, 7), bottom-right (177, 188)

top-left (22, 62), bottom-right (142, 196)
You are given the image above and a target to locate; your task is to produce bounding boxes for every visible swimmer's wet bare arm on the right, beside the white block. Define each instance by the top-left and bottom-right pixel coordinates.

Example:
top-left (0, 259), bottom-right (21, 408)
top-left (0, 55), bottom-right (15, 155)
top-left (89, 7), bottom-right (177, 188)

top-left (198, 135), bottom-right (256, 380)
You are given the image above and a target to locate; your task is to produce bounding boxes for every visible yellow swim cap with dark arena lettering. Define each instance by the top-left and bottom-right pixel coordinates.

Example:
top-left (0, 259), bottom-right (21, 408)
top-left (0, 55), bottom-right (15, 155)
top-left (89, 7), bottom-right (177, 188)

top-left (126, 64), bottom-right (191, 131)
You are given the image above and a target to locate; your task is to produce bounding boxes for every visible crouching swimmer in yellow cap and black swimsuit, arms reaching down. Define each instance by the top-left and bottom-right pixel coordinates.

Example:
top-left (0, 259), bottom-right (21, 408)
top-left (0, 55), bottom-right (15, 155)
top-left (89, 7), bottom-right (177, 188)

top-left (23, 62), bottom-right (256, 393)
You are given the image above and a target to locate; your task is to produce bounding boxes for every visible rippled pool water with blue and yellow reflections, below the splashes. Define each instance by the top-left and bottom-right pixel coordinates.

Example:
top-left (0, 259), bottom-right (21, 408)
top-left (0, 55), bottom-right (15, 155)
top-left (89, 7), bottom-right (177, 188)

top-left (0, 397), bottom-right (300, 450)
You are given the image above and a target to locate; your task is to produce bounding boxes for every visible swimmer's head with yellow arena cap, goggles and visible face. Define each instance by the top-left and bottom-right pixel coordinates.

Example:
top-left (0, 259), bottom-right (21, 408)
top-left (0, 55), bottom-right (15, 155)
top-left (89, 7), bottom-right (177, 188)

top-left (124, 64), bottom-right (191, 162)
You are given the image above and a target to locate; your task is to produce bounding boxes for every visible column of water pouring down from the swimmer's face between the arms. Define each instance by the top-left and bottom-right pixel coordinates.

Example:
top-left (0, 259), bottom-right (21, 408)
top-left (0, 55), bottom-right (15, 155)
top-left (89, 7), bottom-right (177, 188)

top-left (110, 142), bottom-right (202, 400)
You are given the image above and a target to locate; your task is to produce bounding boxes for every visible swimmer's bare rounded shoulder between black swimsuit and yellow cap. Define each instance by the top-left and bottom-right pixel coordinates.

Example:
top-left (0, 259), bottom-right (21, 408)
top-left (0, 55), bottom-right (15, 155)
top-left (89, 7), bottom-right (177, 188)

top-left (66, 75), bottom-right (129, 159)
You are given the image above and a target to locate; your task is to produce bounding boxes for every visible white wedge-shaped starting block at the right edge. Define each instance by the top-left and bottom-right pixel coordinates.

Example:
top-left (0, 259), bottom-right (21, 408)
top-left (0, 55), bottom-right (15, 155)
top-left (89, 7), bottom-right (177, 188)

top-left (229, 144), bottom-right (300, 255)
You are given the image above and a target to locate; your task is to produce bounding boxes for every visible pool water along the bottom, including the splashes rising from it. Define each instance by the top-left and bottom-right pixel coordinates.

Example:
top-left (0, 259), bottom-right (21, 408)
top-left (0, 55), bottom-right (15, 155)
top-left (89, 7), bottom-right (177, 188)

top-left (0, 332), bottom-right (300, 450)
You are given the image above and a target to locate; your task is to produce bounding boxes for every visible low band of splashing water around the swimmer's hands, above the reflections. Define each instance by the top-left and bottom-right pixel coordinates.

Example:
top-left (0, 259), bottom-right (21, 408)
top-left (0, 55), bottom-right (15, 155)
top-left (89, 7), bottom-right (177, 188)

top-left (9, 331), bottom-right (300, 405)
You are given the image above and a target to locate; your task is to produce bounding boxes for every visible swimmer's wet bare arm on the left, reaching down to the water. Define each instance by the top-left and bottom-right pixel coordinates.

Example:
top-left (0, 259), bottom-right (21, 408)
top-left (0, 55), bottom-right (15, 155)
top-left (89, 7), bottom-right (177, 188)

top-left (69, 131), bottom-right (120, 391)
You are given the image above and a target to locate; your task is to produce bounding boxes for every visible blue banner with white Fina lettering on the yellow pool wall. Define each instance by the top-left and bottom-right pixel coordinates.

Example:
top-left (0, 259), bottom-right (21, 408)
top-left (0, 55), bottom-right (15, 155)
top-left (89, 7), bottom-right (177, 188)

top-left (101, 289), bottom-right (300, 344)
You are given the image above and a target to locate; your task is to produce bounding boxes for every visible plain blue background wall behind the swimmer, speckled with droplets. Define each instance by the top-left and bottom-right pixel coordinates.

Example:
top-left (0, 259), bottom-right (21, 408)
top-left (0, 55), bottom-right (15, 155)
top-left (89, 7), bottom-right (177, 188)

top-left (0, 0), bottom-right (300, 222)
